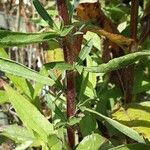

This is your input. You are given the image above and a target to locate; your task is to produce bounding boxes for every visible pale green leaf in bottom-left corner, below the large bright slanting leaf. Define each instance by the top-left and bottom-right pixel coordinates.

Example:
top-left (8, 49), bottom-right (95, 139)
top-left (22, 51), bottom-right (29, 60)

top-left (0, 125), bottom-right (35, 143)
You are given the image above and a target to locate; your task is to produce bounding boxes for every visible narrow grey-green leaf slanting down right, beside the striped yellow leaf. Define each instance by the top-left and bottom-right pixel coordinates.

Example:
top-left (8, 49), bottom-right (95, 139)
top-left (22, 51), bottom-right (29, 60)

top-left (81, 107), bottom-right (145, 143)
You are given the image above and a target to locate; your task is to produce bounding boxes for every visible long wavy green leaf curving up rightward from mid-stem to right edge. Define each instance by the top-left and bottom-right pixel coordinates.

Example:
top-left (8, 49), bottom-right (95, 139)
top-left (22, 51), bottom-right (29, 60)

top-left (84, 51), bottom-right (150, 73)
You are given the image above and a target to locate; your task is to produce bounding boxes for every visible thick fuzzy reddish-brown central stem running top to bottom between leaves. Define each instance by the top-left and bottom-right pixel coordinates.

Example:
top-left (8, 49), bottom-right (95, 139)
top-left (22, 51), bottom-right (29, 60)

top-left (57, 0), bottom-right (75, 148)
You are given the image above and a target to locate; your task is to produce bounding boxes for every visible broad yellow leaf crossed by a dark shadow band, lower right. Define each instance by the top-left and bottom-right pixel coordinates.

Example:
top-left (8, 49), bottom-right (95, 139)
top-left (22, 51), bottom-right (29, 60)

top-left (112, 101), bottom-right (150, 140)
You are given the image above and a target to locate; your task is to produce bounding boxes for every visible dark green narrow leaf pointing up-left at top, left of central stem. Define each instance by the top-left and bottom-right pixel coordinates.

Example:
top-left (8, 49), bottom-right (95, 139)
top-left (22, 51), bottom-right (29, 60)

top-left (33, 0), bottom-right (54, 28)
